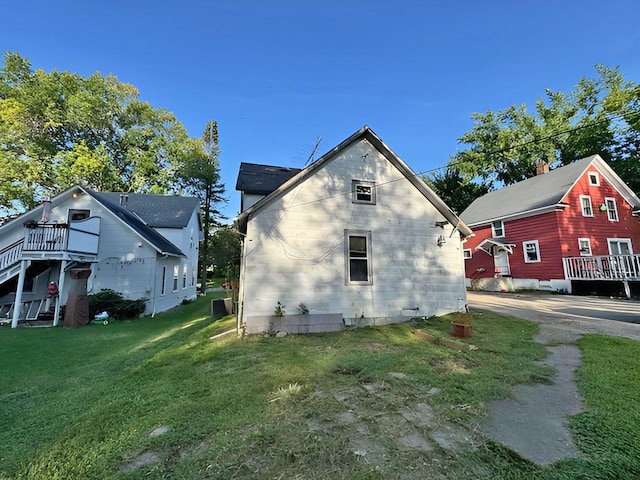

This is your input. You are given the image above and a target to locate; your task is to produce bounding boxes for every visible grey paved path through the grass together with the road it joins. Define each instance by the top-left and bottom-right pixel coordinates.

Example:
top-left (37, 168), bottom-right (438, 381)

top-left (468, 292), bottom-right (640, 465)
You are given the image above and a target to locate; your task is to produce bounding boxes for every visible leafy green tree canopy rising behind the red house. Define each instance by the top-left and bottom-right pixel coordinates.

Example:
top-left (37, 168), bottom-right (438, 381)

top-left (450, 65), bottom-right (640, 195)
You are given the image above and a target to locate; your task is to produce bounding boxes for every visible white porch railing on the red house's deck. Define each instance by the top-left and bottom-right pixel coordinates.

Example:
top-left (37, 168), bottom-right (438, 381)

top-left (562, 254), bottom-right (640, 280)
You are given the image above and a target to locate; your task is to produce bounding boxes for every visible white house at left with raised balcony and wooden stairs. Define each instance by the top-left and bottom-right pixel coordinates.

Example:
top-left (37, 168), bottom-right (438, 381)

top-left (0, 186), bottom-right (202, 327)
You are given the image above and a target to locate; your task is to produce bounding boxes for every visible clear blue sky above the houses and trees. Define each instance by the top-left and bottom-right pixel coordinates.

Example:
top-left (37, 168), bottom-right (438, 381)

top-left (0, 0), bottom-right (640, 217)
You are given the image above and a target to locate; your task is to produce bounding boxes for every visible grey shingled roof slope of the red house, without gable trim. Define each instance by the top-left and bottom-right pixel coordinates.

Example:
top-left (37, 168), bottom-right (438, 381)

top-left (460, 155), bottom-right (597, 225)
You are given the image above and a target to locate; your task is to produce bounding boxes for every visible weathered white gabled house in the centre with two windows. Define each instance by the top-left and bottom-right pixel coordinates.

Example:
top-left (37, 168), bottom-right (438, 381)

top-left (236, 126), bottom-right (471, 333)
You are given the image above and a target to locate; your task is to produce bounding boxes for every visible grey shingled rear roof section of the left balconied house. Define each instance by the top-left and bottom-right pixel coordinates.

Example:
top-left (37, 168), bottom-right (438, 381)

top-left (92, 192), bottom-right (200, 228)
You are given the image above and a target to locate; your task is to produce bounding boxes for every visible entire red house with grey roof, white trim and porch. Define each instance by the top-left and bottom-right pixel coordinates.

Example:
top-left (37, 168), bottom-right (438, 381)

top-left (460, 155), bottom-right (640, 297)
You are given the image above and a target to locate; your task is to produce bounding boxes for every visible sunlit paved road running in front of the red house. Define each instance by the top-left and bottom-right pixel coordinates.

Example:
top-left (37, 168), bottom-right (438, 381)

top-left (467, 292), bottom-right (640, 340)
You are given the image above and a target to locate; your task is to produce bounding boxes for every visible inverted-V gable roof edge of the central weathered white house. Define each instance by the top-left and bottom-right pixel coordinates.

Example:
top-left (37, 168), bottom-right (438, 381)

top-left (235, 125), bottom-right (473, 236)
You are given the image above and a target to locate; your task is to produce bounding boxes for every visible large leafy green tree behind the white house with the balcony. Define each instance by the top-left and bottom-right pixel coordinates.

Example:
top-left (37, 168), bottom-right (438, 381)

top-left (0, 52), bottom-right (190, 212)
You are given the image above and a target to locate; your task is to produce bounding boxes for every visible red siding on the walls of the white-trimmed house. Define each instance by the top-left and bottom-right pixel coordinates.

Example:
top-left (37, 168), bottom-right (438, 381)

top-left (464, 166), bottom-right (640, 280)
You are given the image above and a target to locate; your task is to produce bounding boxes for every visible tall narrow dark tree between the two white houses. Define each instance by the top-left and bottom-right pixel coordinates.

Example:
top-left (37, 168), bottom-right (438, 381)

top-left (177, 120), bottom-right (226, 293)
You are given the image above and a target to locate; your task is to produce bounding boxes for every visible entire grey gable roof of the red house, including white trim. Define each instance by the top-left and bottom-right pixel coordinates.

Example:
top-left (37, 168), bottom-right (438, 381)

top-left (460, 155), bottom-right (640, 226)
